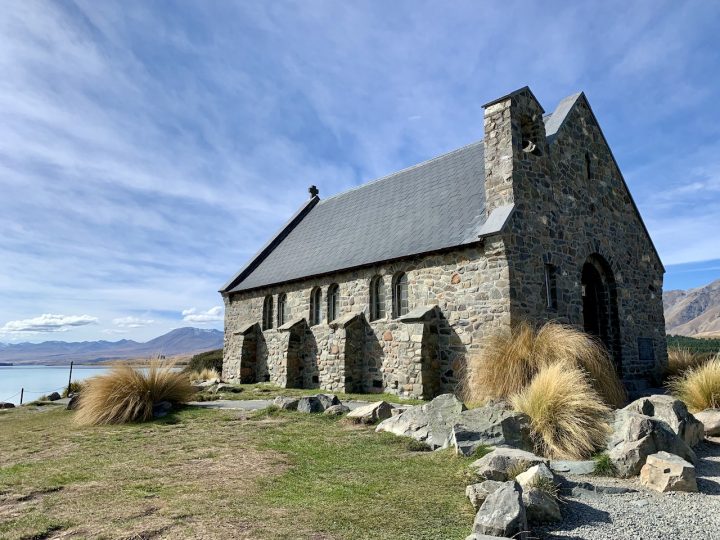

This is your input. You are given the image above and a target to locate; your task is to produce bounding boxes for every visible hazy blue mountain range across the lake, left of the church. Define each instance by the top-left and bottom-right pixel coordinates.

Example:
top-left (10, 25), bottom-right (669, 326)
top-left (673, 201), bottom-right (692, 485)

top-left (0, 327), bottom-right (223, 365)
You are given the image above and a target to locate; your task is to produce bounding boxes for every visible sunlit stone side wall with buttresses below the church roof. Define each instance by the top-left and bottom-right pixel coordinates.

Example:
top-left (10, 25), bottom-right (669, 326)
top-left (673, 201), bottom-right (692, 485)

top-left (223, 243), bottom-right (510, 397)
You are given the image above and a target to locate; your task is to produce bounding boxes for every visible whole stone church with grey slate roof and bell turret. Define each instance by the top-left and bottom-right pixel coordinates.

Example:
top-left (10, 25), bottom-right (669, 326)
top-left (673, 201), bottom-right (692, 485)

top-left (220, 87), bottom-right (667, 398)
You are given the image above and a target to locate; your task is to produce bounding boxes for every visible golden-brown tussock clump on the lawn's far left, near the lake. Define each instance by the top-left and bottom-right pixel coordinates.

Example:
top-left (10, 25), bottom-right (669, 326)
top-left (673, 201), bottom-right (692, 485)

top-left (75, 362), bottom-right (195, 425)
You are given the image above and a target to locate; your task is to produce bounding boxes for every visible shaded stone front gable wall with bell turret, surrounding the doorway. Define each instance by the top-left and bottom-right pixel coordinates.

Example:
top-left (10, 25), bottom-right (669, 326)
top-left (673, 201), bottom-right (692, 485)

top-left (485, 91), bottom-right (667, 379)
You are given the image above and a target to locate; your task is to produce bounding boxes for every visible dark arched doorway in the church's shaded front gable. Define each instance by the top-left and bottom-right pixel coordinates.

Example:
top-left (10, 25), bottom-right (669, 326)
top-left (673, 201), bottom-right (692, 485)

top-left (582, 254), bottom-right (622, 374)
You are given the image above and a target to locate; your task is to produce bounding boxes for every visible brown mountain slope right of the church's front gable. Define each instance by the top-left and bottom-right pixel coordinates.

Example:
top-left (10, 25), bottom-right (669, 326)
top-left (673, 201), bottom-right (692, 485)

top-left (663, 279), bottom-right (720, 338)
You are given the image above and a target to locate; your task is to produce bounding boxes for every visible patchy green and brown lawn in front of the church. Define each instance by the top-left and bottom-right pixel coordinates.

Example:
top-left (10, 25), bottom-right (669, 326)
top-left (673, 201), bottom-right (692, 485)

top-left (0, 406), bottom-right (474, 540)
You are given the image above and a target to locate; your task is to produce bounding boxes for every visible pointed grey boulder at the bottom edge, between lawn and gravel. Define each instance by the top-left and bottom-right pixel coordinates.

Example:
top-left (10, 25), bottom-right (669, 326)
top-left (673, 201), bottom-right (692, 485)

top-left (473, 480), bottom-right (527, 539)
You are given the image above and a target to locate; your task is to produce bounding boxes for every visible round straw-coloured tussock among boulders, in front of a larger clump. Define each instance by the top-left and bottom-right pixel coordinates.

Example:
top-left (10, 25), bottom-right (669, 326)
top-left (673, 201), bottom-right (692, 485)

top-left (511, 363), bottom-right (610, 459)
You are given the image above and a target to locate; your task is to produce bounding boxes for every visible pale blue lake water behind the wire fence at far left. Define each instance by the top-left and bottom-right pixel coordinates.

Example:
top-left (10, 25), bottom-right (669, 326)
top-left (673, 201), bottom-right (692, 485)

top-left (0, 365), bottom-right (108, 405)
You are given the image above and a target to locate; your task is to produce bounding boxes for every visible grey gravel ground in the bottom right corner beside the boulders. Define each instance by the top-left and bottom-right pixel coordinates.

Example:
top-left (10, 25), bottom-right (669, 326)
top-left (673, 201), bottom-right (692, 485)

top-left (531, 442), bottom-right (720, 540)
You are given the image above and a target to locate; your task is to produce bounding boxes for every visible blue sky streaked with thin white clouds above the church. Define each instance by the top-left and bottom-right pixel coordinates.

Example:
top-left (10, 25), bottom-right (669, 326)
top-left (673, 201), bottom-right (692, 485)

top-left (0, 0), bottom-right (720, 342)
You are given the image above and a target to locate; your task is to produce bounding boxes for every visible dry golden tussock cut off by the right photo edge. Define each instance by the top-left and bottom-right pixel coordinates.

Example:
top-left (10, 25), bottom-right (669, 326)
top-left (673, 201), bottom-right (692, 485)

top-left (668, 354), bottom-right (720, 412)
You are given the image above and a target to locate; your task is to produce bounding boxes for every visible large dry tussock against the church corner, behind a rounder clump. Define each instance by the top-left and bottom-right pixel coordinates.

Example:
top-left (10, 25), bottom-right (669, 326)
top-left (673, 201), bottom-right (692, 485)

top-left (463, 322), bottom-right (627, 407)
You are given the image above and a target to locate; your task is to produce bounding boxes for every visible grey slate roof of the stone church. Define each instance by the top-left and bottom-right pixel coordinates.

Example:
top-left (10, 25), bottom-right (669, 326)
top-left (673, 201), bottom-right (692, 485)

top-left (221, 96), bottom-right (575, 293)
